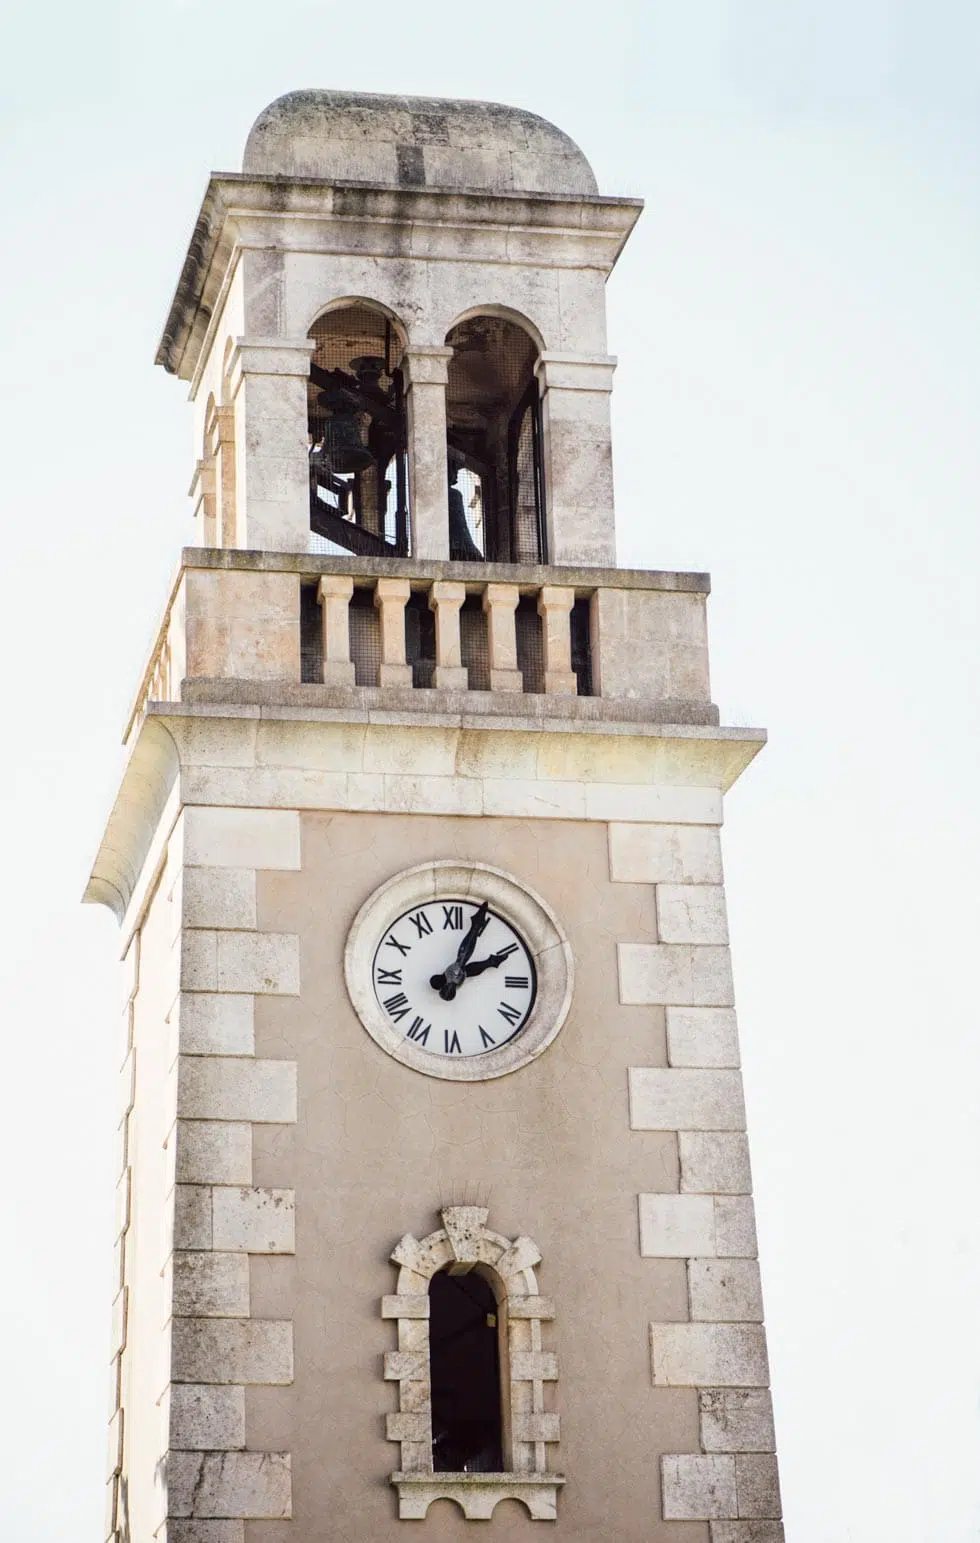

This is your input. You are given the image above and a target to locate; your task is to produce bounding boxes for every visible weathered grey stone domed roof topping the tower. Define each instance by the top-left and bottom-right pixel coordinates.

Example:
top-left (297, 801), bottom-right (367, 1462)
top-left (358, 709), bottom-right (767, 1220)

top-left (242, 91), bottom-right (597, 196)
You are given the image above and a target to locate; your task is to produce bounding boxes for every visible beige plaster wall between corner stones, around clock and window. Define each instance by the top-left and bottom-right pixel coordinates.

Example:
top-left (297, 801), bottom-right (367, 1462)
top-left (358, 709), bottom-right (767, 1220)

top-left (245, 813), bottom-right (708, 1543)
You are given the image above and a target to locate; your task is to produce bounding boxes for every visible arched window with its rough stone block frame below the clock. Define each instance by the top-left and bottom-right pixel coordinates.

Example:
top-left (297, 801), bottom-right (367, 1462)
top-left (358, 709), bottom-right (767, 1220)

top-left (381, 1205), bottom-right (565, 1521)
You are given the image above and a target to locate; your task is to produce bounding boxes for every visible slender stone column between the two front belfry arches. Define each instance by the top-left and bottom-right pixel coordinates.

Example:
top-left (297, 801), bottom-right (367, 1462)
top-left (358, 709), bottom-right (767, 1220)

top-left (403, 346), bottom-right (452, 562)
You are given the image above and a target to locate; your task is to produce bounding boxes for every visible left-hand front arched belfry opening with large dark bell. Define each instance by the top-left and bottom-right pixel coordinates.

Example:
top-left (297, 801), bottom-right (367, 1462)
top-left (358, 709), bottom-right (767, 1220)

top-left (307, 302), bottom-right (409, 557)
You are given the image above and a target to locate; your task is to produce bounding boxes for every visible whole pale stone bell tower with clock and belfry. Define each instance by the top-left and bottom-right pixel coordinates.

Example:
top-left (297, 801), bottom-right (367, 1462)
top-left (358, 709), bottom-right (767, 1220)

top-left (86, 91), bottom-right (782, 1543)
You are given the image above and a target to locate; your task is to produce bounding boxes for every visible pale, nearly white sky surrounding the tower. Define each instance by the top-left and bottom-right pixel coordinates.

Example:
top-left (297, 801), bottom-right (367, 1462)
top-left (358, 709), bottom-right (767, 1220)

top-left (0, 0), bottom-right (980, 1543)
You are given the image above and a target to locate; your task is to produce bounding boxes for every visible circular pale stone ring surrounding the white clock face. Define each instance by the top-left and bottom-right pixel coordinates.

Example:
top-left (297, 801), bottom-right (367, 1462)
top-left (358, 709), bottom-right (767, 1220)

top-left (344, 859), bottom-right (573, 1082)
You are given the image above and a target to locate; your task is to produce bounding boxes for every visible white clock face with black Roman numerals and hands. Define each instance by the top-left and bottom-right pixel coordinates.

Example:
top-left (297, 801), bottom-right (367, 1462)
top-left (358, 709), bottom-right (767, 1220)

top-left (372, 896), bottom-right (537, 1058)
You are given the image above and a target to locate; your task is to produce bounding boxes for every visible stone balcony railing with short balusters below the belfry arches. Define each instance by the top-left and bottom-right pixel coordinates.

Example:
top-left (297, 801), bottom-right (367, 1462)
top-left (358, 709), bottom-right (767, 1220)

top-left (127, 548), bottom-right (718, 738)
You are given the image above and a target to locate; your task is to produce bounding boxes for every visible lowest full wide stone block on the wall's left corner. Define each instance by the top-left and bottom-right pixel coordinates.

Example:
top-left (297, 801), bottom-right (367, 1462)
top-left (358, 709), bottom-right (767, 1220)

top-left (167, 1452), bottom-right (292, 1520)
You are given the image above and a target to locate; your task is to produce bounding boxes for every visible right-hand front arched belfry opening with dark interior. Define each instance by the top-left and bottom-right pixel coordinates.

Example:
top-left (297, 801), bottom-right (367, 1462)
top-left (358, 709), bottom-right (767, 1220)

top-left (446, 315), bottom-right (548, 563)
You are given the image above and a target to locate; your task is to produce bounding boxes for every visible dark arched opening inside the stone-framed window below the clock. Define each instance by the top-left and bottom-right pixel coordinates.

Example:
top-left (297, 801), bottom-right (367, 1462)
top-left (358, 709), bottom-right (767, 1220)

top-left (429, 1270), bottom-right (503, 1474)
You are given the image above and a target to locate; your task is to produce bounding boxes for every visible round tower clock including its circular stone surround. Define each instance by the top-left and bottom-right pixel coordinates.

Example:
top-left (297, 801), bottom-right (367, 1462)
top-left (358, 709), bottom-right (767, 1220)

top-left (344, 859), bottom-right (573, 1082)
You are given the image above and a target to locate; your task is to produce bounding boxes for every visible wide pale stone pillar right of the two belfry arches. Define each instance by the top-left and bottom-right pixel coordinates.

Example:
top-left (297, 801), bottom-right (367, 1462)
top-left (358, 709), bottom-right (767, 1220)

top-left (536, 353), bottom-right (616, 568)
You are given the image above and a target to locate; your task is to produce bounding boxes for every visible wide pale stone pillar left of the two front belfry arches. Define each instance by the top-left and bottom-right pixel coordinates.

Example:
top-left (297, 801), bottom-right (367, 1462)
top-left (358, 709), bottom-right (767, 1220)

top-left (222, 338), bottom-right (315, 552)
